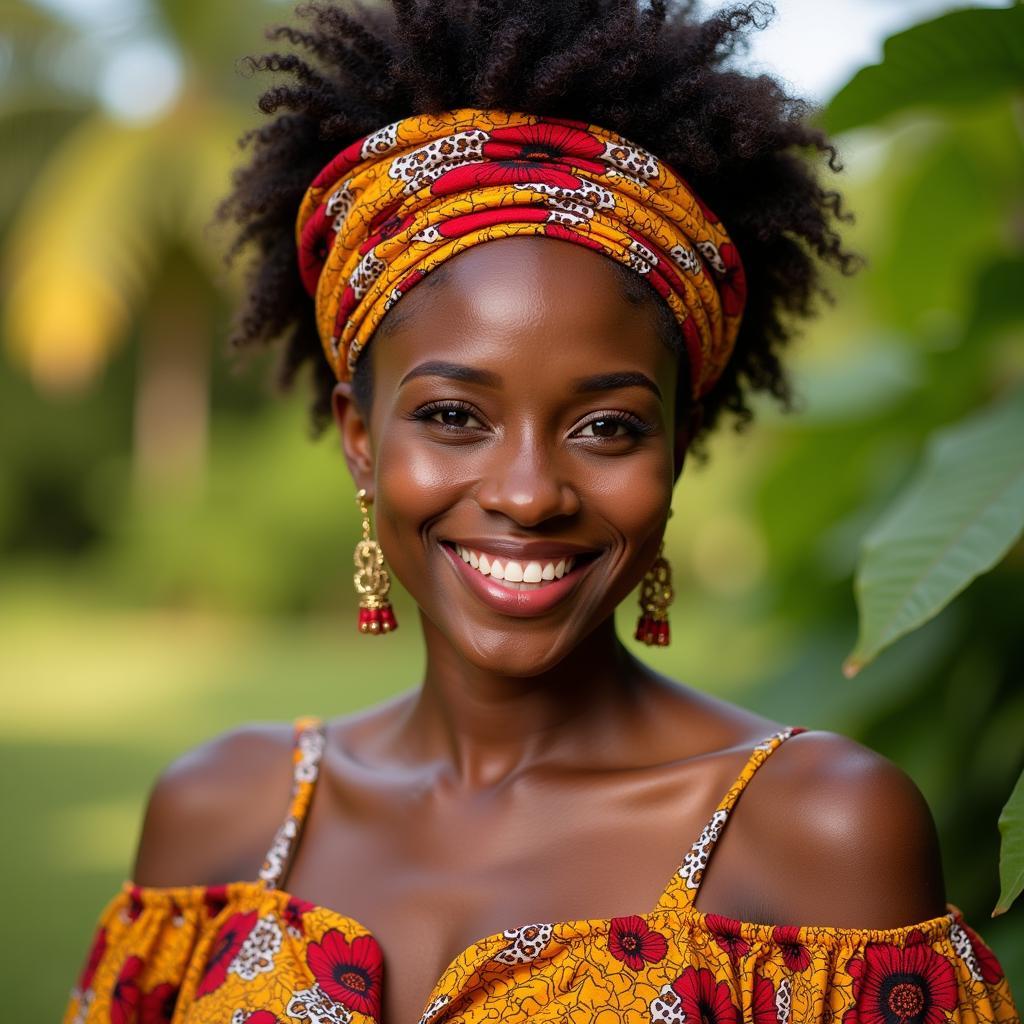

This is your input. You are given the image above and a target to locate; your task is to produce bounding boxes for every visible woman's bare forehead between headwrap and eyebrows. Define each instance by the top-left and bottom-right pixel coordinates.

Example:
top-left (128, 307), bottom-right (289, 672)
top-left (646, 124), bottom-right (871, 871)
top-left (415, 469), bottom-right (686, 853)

top-left (371, 236), bottom-right (677, 385)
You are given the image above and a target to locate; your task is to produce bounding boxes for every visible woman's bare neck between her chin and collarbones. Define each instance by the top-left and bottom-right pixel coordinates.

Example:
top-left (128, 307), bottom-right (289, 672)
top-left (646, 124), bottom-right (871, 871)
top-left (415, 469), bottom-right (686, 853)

top-left (394, 616), bottom-right (641, 788)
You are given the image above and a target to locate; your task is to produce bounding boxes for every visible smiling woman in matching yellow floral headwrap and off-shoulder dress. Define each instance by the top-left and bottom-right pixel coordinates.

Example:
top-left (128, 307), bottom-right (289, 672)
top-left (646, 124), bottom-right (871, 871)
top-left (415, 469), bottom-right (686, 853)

top-left (67, 0), bottom-right (1018, 1024)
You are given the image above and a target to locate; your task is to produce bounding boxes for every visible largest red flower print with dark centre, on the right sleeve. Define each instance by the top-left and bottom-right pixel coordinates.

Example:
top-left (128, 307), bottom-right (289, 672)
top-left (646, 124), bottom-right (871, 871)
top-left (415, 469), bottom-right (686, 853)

top-left (843, 932), bottom-right (956, 1024)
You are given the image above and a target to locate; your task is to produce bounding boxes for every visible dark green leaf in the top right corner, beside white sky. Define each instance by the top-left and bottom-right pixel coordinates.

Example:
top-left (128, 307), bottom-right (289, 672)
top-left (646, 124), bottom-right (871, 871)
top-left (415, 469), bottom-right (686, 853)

top-left (822, 4), bottom-right (1024, 132)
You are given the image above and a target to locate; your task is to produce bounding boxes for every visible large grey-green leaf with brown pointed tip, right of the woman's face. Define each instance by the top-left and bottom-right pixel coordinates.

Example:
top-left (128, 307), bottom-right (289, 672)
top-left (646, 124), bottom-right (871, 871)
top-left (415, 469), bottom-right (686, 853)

top-left (843, 389), bottom-right (1024, 676)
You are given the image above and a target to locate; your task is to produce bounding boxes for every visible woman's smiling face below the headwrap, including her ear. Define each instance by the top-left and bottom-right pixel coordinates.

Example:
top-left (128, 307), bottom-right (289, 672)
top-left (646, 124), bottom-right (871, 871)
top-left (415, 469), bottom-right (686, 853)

top-left (335, 237), bottom-right (685, 676)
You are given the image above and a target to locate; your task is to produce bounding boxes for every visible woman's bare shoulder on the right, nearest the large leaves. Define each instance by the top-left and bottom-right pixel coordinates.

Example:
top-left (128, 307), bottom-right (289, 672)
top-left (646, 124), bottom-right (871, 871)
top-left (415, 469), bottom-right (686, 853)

top-left (735, 730), bottom-right (946, 928)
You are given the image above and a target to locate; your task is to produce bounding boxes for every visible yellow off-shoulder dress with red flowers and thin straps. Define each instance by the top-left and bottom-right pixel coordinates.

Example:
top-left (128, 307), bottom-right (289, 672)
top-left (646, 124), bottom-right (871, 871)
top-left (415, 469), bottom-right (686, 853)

top-left (65, 720), bottom-right (1020, 1024)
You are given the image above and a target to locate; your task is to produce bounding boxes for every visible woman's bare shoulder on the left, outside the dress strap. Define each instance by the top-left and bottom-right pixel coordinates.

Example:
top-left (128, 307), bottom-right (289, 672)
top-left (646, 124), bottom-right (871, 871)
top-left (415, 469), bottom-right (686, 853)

top-left (132, 722), bottom-right (293, 886)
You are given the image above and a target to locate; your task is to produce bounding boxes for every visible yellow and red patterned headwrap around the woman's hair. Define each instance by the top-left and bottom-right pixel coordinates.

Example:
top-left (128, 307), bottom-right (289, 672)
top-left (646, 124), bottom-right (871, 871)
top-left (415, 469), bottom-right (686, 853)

top-left (296, 108), bottom-right (746, 398)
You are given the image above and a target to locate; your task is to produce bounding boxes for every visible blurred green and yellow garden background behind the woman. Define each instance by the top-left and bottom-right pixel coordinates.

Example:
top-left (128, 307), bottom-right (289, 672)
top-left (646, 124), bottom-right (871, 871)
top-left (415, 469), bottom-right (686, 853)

top-left (0, 0), bottom-right (1024, 1021)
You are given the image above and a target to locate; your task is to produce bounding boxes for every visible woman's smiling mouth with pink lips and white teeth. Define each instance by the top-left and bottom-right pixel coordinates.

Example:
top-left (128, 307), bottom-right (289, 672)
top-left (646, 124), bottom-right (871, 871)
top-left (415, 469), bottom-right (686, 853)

top-left (441, 542), bottom-right (597, 617)
